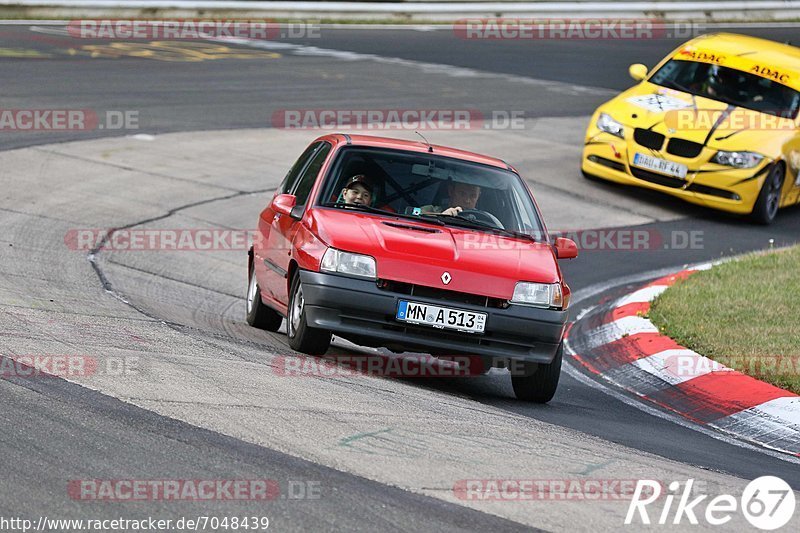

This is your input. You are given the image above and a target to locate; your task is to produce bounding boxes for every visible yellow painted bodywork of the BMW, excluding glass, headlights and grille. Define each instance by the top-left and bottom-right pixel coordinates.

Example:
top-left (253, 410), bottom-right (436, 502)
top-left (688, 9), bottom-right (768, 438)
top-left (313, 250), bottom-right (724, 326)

top-left (581, 33), bottom-right (800, 214)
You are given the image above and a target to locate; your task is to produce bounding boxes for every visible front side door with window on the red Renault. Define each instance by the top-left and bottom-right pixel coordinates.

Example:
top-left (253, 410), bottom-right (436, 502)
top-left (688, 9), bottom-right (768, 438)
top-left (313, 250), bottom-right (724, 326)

top-left (264, 142), bottom-right (332, 305)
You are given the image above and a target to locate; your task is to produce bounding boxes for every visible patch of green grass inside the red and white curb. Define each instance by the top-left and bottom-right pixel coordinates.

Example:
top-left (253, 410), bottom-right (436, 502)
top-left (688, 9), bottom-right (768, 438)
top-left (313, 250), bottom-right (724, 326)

top-left (649, 246), bottom-right (800, 394)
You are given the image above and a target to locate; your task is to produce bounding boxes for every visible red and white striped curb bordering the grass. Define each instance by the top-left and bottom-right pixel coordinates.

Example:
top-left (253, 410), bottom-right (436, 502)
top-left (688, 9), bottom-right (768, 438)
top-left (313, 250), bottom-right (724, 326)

top-left (567, 264), bottom-right (800, 456)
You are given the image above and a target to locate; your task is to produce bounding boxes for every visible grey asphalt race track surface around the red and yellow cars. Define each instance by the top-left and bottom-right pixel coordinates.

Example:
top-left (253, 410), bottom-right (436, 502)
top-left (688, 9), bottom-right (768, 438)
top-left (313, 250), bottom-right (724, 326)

top-left (0, 24), bottom-right (800, 531)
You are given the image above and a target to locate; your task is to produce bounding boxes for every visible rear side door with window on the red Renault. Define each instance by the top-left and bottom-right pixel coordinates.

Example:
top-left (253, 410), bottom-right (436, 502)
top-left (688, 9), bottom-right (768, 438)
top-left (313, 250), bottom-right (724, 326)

top-left (253, 142), bottom-right (322, 308)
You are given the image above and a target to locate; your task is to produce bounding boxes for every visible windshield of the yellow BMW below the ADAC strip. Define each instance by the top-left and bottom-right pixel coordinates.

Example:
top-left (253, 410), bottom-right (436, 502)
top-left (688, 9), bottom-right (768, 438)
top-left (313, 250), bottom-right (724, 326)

top-left (648, 59), bottom-right (800, 119)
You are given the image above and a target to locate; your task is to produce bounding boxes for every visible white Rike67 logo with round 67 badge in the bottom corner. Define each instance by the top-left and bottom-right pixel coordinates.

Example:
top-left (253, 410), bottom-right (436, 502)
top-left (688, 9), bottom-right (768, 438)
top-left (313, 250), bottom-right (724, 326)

top-left (625, 476), bottom-right (795, 531)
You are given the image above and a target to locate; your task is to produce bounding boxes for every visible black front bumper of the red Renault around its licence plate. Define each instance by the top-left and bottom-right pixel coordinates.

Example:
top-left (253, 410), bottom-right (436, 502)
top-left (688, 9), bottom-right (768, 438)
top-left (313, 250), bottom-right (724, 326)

top-left (300, 270), bottom-right (567, 363)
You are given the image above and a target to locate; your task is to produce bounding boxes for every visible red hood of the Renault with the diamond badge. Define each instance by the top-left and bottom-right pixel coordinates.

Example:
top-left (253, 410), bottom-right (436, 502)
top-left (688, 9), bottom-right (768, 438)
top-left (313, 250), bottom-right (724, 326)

top-left (311, 208), bottom-right (561, 299)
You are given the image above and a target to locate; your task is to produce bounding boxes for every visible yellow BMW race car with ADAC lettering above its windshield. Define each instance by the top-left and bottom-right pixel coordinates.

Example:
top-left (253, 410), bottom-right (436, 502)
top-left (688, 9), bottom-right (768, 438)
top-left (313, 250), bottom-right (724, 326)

top-left (581, 33), bottom-right (800, 224)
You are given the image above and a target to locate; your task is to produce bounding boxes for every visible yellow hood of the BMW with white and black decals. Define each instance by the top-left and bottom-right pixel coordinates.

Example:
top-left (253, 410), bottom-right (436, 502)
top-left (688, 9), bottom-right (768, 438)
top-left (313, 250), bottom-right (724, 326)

top-left (601, 82), bottom-right (797, 152)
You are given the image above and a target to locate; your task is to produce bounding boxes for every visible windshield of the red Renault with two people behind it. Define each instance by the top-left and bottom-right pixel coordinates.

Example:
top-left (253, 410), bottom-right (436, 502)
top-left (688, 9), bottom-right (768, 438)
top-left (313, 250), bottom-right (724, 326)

top-left (318, 147), bottom-right (546, 240)
